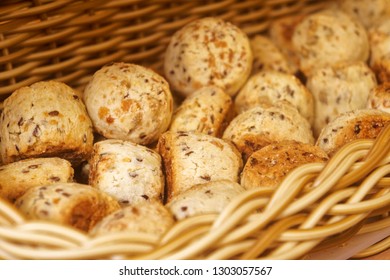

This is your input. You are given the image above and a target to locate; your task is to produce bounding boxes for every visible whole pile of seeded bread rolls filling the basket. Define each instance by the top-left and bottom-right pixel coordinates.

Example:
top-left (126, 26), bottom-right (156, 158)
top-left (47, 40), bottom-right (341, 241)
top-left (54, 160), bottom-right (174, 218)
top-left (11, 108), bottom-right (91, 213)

top-left (0, 0), bottom-right (390, 241)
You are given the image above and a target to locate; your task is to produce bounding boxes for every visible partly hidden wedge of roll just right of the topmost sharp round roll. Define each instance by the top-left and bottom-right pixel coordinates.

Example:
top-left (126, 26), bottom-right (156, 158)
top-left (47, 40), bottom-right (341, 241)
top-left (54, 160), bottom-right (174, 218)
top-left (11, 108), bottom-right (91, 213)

top-left (250, 35), bottom-right (294, 75)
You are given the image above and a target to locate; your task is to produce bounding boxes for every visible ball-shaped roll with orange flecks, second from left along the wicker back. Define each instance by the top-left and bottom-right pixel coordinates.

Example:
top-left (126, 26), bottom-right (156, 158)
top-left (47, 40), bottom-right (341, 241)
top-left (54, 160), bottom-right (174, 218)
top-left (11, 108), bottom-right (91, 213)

top-left (84, 62), bottom-right (173, 145)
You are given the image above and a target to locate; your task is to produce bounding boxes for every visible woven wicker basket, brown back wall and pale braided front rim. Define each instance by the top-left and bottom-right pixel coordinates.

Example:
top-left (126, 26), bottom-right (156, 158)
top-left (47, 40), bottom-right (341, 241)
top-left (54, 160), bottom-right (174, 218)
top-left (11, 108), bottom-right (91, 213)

top-left (0, 0), bottom-right (390, 259)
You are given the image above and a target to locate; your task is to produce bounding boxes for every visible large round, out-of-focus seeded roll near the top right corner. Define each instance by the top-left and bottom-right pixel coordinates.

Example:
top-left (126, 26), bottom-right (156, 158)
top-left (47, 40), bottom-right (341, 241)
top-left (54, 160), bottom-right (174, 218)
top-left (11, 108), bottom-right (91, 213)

top-left (292, 9), bottom-right (369, 76)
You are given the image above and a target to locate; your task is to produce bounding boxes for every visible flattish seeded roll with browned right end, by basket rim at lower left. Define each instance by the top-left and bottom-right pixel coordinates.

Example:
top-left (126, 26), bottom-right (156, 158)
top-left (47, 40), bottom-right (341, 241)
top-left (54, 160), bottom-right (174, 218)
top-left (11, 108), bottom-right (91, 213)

top-left (15, 183), bottom-right (120, 231)
